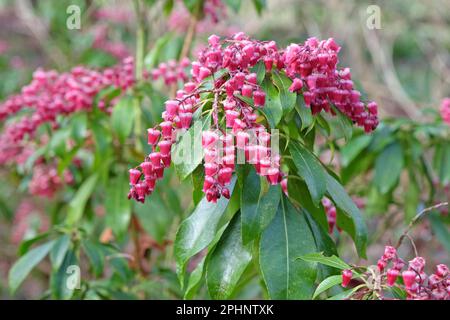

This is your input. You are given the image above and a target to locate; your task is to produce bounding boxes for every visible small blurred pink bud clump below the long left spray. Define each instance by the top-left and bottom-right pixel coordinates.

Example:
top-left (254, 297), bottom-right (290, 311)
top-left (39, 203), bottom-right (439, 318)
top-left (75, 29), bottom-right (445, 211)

top-left (28, 163), bottom-right (73, 198)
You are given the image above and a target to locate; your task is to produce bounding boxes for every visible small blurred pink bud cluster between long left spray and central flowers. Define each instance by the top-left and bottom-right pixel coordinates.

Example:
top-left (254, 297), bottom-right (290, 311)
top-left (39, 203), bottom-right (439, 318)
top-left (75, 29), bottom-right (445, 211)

top-left (151, 58), bottom-right (191, 86)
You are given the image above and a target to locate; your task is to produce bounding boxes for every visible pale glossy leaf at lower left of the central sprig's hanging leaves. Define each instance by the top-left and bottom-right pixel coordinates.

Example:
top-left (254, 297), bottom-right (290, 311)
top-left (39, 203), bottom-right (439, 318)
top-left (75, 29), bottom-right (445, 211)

top-left (174, 177), bottom-right (236, 284)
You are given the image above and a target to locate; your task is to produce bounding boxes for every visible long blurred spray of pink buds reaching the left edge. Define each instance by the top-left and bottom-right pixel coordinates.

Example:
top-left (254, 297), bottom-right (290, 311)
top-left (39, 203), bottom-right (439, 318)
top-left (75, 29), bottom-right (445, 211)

top-left (0, 58), bottom-right (134, 163)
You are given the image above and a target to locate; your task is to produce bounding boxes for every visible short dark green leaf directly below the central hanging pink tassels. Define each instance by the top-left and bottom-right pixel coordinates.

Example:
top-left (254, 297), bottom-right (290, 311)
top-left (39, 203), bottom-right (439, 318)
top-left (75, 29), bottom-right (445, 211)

top-left (241, 169), bottom-right (281, 244)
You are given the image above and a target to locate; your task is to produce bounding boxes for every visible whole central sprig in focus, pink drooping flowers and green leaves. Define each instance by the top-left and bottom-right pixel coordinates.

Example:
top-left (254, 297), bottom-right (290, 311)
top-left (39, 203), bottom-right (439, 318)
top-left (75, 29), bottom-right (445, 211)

top-left (128, 33), bottom-right (378, 299)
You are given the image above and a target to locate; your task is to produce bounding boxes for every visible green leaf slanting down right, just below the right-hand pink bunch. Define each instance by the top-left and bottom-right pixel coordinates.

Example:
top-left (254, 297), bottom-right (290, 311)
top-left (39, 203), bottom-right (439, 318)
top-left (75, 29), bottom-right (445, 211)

top-left (289, 141), bottom-right (327, 206)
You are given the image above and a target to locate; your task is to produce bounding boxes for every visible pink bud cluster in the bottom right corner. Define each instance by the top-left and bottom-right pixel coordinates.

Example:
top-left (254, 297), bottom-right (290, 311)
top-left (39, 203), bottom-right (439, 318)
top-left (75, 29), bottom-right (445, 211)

top-left (342, 246), bottom-right (450, 300)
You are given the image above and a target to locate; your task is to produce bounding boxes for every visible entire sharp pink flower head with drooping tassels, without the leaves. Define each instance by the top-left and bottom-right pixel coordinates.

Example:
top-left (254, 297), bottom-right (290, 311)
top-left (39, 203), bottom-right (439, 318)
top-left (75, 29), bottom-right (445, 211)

top-left (129, 33), bottom-right (378, 202)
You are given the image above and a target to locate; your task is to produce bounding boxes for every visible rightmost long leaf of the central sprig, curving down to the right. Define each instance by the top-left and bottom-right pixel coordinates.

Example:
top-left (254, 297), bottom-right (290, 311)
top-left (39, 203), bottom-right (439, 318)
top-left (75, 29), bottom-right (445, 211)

top-left (327, 174), bottom-right (367, 257)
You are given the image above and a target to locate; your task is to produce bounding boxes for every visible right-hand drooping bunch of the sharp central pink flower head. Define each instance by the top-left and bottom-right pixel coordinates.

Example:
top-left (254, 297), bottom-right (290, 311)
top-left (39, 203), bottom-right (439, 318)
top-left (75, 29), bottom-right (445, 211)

top-left (282, 38), bottom-right (378, 132)
